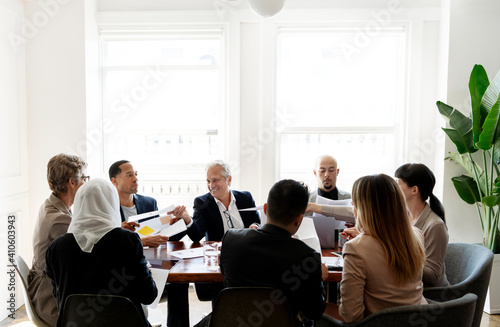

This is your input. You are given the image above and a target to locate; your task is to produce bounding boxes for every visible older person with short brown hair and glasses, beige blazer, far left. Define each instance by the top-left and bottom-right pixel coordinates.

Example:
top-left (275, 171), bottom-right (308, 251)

top-left (28, 153), bottom-right (89, 326)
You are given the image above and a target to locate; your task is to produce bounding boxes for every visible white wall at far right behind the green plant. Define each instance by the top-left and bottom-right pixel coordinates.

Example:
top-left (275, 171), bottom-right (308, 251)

top-left (439, 0), bottom-right (500, 246)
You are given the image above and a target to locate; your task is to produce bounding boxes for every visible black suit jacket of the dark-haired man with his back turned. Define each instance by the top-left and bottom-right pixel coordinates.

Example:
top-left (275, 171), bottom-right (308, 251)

top-left (220, 224), bottom-right (326, 326)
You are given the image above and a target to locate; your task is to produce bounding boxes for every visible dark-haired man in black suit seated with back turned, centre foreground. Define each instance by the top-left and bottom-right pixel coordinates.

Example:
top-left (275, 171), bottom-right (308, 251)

top-left (214, 180), bottom-right (327, 326)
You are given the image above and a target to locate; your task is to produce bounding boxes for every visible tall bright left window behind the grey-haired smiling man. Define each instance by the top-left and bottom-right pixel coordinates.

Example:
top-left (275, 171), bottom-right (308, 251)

top-left (101, 29), bottom-right (226, 205)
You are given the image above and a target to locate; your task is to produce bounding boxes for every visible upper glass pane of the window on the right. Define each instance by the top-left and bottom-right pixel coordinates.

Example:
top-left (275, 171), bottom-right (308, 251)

top-left (277, 29), bottom-right (405, 127)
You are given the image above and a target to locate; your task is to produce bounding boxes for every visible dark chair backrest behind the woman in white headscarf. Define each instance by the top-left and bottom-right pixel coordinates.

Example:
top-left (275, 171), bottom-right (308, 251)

top-left (58, 294), bottom-right (146, 327)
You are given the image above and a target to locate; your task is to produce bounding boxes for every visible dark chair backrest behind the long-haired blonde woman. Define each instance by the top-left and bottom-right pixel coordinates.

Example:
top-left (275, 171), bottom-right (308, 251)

top-left (315, 294), bottom-right (477, 327)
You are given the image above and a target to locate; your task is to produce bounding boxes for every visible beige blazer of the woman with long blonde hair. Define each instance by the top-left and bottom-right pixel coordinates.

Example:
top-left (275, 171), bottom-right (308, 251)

top-left (339, 234), bottom-right (427, 322)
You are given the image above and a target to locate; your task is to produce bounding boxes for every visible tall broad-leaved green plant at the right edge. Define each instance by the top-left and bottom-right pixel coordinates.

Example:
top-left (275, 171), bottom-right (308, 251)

top-left (437, 65), bottom-right (500, 254)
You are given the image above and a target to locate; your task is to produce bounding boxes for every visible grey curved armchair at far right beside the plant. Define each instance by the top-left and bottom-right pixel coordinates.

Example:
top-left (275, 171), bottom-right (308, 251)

top-left (424, 243), bottom-right (494, 327)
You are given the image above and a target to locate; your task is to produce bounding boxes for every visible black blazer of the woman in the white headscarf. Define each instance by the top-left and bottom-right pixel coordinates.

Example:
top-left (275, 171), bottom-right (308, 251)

top-left (45, 228), bottom-right (158, 326)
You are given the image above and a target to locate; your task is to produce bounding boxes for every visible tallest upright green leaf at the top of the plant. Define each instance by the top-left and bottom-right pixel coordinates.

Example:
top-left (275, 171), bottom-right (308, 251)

top-left (469, 65), bottom-right (490, 144)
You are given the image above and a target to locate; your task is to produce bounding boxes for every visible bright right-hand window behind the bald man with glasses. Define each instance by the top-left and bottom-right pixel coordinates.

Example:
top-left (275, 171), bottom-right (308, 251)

top-left (276, 28), bottom-right (406, 190)
